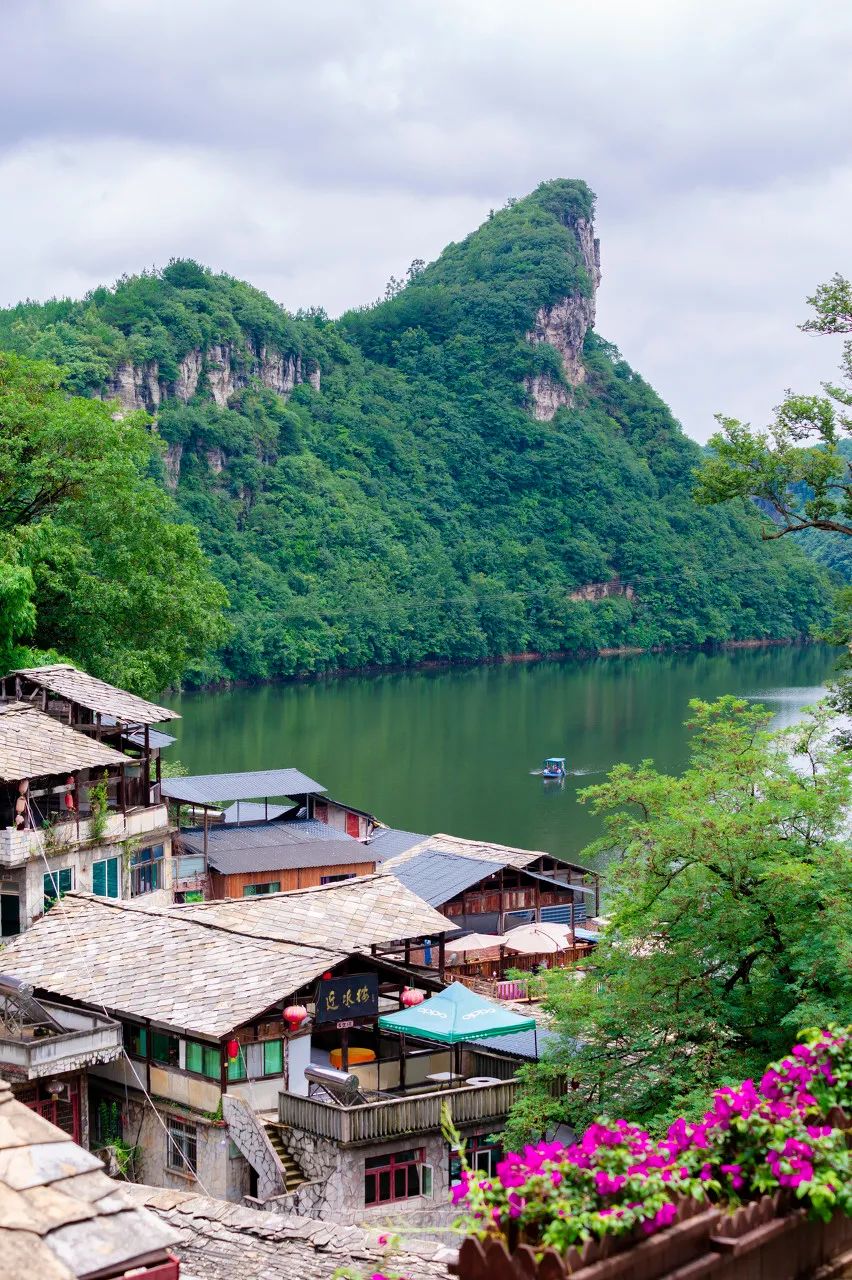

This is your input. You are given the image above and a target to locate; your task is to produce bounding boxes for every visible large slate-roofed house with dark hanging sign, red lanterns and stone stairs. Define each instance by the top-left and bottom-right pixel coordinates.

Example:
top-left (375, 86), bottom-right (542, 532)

top-left (0, 876), bottom-right (532, 1222)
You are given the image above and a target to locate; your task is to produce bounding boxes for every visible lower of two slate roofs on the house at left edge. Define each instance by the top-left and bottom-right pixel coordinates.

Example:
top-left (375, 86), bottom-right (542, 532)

top-left (0, 703), bottom-right (130, 782)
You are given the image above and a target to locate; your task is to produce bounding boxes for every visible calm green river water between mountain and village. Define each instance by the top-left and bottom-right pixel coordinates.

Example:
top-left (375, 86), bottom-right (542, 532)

top-left (169, 646), bottom-right (835, 855)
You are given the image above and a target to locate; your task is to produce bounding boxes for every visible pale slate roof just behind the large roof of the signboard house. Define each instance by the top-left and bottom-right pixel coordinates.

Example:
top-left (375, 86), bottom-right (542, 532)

top-left (170, 876), bottom-right (457, 952)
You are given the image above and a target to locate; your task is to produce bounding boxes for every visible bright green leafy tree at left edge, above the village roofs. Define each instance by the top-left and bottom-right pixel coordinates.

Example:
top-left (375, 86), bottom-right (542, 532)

top-left (0, 355), bottom-right (226, 694)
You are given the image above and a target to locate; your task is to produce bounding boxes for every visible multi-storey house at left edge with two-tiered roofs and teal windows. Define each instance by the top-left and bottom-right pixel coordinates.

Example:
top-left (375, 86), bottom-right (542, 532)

top-left (0, 664), bottom-right (175, 937)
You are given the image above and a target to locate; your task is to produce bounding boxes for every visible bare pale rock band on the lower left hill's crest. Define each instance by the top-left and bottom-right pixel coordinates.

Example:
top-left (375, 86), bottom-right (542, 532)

top-left (101, 342), bottom-right (320, 413)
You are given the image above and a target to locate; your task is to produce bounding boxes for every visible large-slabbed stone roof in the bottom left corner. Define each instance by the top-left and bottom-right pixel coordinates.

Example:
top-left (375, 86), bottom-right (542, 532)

top-left (0, 1080), bottom-right (178, 1280)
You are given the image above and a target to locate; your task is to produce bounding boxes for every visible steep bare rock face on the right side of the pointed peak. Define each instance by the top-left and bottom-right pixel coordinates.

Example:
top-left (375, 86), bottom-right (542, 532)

top-left (526, 218), bottom-right (600, 422)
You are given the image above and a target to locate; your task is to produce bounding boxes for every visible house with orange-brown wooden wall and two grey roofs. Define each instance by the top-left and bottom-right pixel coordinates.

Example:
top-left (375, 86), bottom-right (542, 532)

top-left (162, 769), bottom-right (376, 901)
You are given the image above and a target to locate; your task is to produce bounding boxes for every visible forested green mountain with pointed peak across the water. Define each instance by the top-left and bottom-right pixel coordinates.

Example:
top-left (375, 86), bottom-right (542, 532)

top-left (0, 180), bottom-right (828, 678)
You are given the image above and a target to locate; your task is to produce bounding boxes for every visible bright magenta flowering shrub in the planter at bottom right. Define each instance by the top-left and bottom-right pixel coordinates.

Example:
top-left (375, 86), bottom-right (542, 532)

top-left (453, 1028), bottom-right (852, 1251)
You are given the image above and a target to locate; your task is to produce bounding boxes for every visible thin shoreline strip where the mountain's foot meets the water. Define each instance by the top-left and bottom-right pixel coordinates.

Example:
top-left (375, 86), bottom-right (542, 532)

top-left (173, 636), bottom-right (817, 694)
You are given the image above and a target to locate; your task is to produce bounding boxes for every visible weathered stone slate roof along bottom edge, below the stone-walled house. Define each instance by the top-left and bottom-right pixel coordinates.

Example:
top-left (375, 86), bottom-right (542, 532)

top-left (128, 1185), bottom-right (457, 1280)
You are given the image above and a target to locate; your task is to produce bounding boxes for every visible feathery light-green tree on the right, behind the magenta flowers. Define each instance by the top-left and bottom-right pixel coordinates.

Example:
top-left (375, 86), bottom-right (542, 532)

top-left (509, 696), bottom-right (852, 1143)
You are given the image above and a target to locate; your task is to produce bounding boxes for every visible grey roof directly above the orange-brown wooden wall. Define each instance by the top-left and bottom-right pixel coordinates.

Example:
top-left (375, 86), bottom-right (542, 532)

top-left (180, 819), bottom-right (375, 876)
